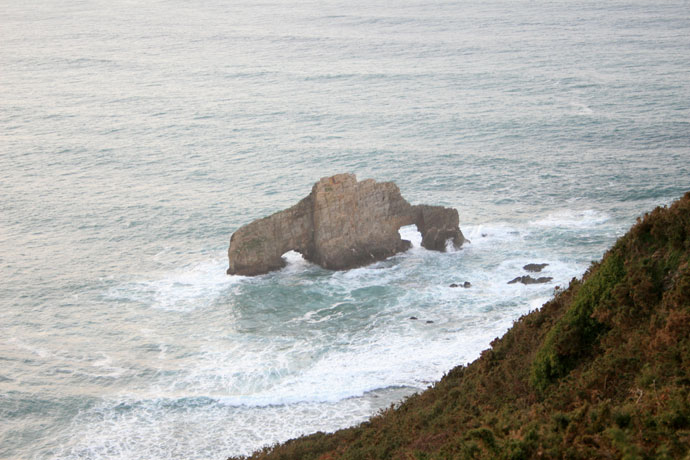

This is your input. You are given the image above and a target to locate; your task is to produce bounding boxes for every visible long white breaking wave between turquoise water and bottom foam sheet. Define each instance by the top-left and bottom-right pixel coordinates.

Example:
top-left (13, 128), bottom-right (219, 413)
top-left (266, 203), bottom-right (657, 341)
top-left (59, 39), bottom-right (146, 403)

top-left (126, 312), bottom-right (498, 407)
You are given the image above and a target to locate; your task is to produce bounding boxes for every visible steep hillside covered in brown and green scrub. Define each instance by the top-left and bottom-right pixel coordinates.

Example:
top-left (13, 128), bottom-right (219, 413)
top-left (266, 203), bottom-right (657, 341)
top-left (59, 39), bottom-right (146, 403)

top-left (231, 193), bottom-right (690, 460)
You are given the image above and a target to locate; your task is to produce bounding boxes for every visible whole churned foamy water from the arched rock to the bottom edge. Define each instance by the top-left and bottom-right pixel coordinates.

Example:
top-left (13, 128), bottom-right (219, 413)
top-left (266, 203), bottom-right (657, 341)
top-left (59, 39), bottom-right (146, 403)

top-left (80, 219), bottom-right (591, 459)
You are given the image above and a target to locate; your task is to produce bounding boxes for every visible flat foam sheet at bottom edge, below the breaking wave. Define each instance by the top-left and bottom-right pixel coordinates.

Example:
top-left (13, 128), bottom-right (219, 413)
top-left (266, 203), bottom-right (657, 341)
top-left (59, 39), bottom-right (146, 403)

top-left (50, 398), bottom-right (376, 460)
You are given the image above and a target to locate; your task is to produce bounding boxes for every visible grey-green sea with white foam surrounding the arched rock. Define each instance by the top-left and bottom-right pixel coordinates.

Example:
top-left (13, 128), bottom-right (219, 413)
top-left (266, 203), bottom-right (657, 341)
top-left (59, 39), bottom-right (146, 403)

top-left (0, 0), bottom-right (690, 460)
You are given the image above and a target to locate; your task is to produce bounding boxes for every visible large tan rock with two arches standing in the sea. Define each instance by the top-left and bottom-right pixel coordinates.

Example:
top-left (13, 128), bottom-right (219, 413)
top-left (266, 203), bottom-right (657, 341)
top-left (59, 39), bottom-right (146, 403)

top-left (228, 174), bottom-right (465, 276)
